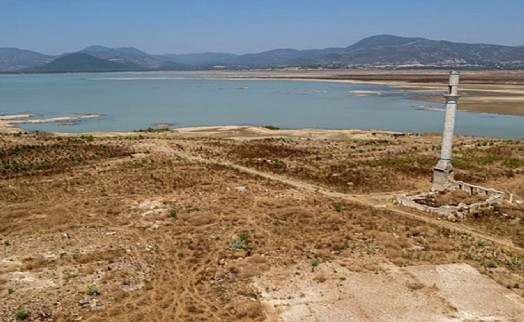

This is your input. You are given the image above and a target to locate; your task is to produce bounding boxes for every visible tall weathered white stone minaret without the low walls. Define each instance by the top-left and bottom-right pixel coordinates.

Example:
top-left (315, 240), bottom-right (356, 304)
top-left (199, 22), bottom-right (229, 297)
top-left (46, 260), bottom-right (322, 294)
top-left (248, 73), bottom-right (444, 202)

top-left (432, 71), bottom-right (460, 191)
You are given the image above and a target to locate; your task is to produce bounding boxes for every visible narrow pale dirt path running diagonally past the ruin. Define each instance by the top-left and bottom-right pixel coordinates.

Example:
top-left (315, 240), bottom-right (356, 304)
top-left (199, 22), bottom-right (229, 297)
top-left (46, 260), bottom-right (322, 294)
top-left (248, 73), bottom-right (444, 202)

top-left (157, 145), bottom-right (524, 254)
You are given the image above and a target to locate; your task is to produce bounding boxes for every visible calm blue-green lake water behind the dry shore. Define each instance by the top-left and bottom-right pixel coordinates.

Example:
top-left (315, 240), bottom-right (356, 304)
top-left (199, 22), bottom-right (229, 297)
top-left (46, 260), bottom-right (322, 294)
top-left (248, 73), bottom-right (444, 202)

top-left (0, 72), bottom-right (524, 138)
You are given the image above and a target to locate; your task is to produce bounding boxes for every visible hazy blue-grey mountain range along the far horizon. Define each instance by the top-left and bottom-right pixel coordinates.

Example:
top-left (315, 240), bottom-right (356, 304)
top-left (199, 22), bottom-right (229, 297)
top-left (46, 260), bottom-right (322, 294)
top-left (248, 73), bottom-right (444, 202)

top-left (0, 35), bottom-right (524, 73)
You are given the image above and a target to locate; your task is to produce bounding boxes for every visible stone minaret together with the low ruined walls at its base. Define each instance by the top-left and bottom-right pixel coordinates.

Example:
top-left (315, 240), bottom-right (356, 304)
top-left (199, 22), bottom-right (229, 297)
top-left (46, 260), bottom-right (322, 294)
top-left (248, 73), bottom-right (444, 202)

top-left (397, 71), bottom-right (504, 219)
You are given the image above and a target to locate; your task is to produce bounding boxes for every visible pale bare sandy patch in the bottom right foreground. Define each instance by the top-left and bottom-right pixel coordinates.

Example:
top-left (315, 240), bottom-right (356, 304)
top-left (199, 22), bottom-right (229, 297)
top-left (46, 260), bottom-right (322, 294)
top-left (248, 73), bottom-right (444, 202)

top-left (256, 261), bottom-right (524, 322)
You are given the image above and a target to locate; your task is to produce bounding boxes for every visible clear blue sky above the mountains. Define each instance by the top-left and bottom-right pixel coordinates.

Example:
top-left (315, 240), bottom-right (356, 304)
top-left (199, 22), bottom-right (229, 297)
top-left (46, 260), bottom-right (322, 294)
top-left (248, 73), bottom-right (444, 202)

top-left (0, 0), bottom-right (524, 54)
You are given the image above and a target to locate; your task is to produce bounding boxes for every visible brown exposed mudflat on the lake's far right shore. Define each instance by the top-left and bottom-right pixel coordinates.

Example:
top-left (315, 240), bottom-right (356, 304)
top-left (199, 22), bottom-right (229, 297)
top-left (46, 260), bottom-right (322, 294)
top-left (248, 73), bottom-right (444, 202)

top-left (210, 69), bottom-right (524, 115)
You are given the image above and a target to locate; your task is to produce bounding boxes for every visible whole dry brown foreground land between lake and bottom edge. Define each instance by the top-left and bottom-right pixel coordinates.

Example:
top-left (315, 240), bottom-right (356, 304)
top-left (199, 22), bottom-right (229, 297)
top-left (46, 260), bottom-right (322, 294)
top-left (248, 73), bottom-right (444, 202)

top-left (0, 127), bottom-right (524, 321)
